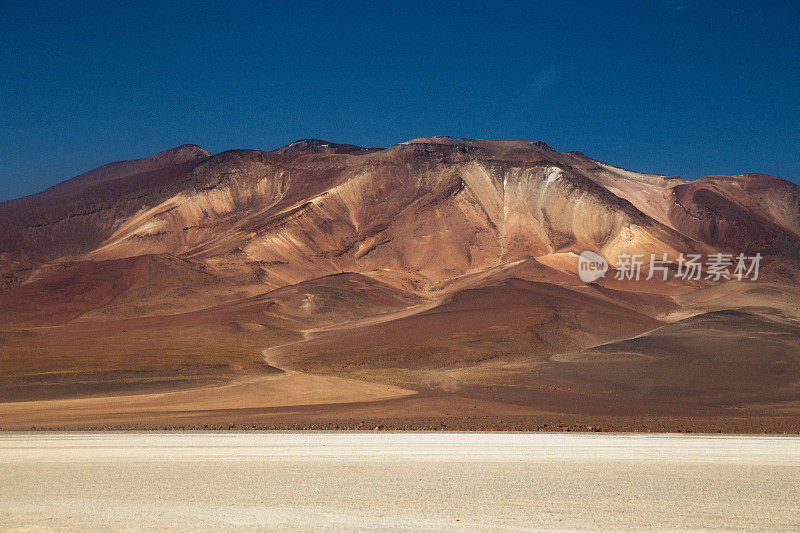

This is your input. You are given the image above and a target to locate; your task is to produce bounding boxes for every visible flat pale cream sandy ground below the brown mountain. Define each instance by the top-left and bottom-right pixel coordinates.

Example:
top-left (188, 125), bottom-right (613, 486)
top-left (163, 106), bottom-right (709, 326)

top-left (0, 433), bottom-right (800, 531)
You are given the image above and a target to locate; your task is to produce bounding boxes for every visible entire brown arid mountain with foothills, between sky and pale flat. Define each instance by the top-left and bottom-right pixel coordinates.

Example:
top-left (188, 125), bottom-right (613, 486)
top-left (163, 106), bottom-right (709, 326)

top-left (0, 137), bottom-right (800, 433)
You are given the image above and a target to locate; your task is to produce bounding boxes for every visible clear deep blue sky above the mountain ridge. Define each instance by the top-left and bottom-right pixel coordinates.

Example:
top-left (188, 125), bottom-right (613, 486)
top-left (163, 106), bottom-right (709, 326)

top-left (0, 0), bottom-right (800, 199)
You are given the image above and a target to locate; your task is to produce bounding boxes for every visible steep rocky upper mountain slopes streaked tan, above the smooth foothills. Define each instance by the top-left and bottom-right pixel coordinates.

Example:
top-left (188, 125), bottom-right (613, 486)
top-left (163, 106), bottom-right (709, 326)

top-left (0, 137), bottom-right (800, 288)
